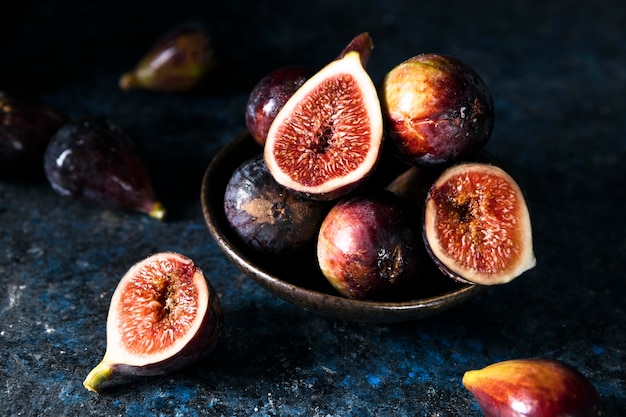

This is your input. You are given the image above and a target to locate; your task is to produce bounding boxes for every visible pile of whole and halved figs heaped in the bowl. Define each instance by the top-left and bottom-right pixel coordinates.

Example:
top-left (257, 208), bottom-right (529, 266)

top-left (224, 33), bottom-right (535, 300)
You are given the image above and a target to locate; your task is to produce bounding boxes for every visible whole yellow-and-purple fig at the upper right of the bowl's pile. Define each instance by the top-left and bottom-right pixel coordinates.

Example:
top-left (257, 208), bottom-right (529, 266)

top-left (380, 54), bottom-right (494, 165)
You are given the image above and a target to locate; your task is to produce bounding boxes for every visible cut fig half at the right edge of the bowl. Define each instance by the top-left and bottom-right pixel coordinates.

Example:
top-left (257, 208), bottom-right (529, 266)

top-left (423, 162), bottom-right (536, 285)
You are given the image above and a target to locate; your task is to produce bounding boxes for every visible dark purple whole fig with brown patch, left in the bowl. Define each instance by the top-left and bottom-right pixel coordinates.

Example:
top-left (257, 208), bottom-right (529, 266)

top-left (224, 155), bottom-right (326, 256)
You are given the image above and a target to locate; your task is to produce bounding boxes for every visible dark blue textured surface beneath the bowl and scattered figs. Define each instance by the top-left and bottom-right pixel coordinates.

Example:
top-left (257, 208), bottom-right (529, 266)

top-left (0, 0), bottom-right (626, 417)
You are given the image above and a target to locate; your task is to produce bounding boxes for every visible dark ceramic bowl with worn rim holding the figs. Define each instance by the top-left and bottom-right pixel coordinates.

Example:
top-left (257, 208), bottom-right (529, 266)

top-left (201, 133), bottom-right (483, 323)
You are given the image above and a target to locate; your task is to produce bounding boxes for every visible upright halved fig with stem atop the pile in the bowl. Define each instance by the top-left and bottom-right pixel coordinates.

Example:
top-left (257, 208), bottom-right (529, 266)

top-left (264, 35), bottom-right (383, 200)
